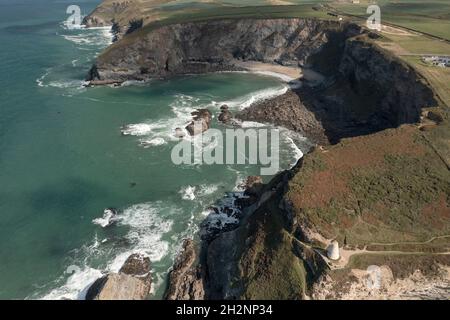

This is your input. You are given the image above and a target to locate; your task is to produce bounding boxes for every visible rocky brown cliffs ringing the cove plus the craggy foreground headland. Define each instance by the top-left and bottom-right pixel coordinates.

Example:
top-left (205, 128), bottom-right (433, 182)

top-left (82, 14), bottom-right (448, 300)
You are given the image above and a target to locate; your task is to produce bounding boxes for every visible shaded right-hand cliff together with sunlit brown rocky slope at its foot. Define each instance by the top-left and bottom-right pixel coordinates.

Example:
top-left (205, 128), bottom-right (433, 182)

top-left (238, 35), bottom-right (437, 144)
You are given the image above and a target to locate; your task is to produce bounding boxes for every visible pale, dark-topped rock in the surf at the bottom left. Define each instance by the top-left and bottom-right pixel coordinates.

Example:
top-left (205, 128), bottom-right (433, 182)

top-left (86, 254), bottom-right (152, 300)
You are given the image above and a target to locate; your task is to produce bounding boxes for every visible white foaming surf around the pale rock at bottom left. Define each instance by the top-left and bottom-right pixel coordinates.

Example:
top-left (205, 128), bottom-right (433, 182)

top-left (41, 201), bottom-right (179, 300)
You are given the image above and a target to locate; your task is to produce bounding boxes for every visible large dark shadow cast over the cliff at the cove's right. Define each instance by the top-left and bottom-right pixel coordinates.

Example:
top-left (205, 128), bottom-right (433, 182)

top-left (294, 33), bottom-right (438, 144)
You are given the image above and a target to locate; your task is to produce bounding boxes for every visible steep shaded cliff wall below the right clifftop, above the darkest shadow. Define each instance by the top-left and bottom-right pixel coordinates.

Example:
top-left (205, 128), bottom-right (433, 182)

top-left (339, 40), bottom-right (437, 127)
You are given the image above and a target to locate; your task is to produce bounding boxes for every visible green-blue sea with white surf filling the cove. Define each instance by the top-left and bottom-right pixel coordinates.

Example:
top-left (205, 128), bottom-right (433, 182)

top-left (0, 0), bottom-right (308, 299)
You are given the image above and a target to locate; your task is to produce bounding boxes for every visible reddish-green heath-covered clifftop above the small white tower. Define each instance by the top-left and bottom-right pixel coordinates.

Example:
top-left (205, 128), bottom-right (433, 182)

top-left (287, 125), bottom-right (450, 246)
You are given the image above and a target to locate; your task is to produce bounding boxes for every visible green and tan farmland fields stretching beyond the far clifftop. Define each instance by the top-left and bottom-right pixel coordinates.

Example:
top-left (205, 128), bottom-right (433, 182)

top-left (91, 0), bottom-right (450, 40)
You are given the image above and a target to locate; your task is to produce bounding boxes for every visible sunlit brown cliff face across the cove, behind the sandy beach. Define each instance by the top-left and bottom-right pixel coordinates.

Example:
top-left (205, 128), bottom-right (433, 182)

top-left (88, 19), bottom-right (360, 82)
